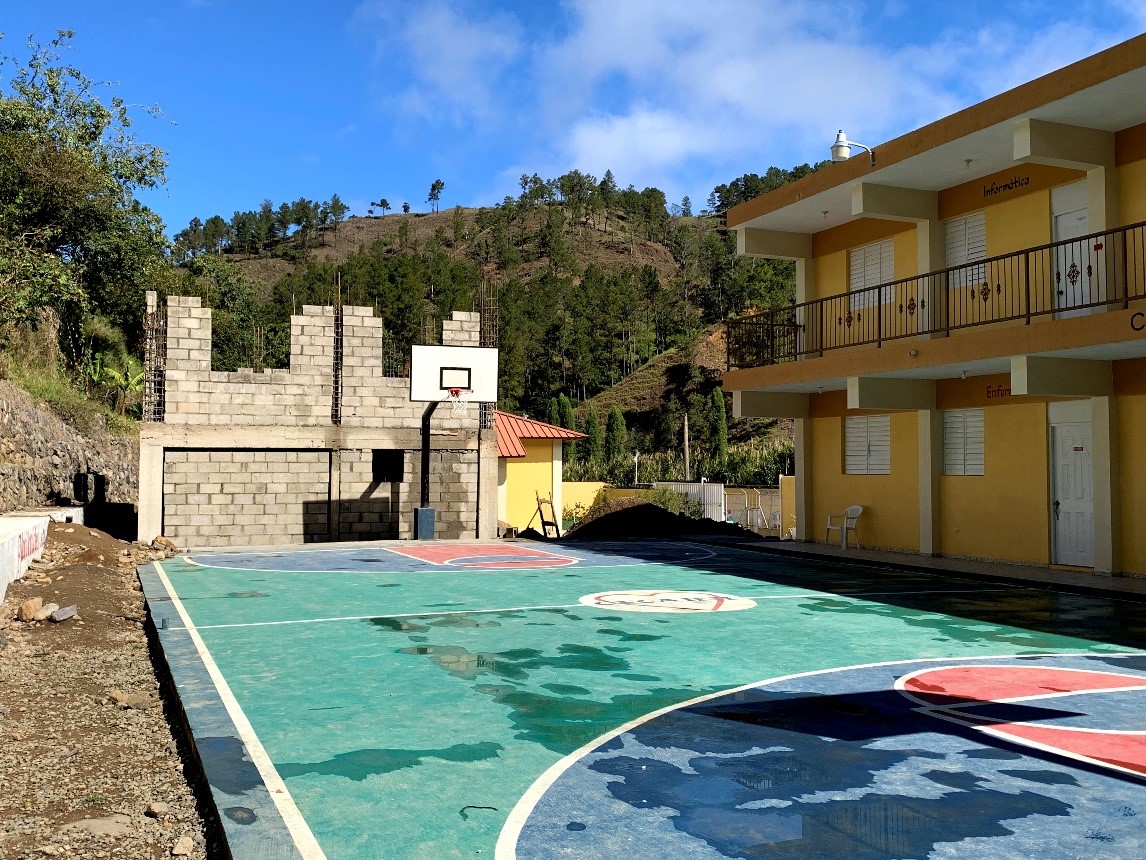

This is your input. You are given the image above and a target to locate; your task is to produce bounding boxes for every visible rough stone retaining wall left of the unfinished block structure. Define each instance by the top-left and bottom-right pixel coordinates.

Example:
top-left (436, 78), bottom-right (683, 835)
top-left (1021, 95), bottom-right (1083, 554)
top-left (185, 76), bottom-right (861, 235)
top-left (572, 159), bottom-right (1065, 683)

top-left (0, 381), bottom-right (139, 513)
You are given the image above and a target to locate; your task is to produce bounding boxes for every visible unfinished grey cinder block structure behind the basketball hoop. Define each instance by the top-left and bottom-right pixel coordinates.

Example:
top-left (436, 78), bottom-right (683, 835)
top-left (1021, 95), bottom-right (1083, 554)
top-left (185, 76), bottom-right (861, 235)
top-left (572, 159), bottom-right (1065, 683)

top-left (139, 292), bottom-right (497, 547)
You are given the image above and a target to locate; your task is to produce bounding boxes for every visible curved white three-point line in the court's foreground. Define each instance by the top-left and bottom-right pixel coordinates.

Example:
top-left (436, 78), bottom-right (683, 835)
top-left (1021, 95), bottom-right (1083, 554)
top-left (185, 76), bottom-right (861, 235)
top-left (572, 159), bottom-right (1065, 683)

top-left (494, 651), bottom-right (1143, 860)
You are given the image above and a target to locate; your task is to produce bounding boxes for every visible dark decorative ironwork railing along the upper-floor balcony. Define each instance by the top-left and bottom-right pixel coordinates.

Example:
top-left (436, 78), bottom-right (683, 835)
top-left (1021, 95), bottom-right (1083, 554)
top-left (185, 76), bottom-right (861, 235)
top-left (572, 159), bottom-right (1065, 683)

top-left (728, 221), bottom-right (1146, 369)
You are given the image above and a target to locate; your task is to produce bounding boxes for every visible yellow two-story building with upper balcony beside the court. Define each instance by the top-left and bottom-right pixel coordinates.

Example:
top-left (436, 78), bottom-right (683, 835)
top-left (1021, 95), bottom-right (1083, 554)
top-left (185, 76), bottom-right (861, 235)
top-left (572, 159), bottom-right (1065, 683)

top-left (724, 36), bottom-right (1146, 574)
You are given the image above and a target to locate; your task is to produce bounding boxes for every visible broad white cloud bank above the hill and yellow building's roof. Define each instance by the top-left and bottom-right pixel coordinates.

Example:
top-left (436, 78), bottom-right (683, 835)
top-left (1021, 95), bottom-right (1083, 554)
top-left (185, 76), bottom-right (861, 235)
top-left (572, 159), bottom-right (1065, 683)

top-left (358, 0), bottom-right (1146, 201)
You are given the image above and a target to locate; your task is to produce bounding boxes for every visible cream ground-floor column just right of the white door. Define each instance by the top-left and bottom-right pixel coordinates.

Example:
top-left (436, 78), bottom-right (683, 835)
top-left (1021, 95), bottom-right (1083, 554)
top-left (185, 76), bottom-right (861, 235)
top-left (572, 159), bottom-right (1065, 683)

top-left (1090, 397), bottom-right (1122, 574)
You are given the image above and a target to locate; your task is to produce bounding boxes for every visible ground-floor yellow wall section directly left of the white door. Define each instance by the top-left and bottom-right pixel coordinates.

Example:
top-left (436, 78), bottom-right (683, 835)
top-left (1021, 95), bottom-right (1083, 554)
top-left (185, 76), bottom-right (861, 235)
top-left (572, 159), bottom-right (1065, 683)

top-left (940, 404), bottom-right (1050, 564)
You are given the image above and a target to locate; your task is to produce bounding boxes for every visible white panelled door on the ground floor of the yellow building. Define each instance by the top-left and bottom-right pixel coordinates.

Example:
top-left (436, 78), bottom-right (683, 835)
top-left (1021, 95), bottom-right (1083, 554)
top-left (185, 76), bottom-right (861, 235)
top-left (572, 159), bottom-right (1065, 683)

top-left (1051, 423), bottom-right (1094, 568)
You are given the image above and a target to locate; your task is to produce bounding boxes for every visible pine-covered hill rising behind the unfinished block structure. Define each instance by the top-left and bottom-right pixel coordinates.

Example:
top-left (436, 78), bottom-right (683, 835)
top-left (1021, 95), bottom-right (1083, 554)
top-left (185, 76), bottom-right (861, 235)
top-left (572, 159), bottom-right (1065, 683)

top-left (166, 162), bottom-right (811, 426)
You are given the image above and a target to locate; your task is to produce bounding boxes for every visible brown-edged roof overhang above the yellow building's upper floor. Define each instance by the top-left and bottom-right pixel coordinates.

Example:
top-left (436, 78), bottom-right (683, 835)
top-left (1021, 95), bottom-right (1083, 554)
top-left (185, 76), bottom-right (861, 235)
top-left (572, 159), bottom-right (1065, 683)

top-left (727, 34), bottom-right (1146, 234)
